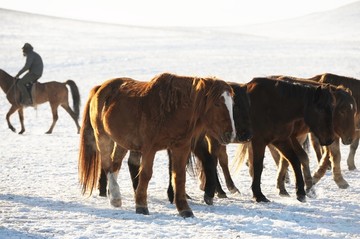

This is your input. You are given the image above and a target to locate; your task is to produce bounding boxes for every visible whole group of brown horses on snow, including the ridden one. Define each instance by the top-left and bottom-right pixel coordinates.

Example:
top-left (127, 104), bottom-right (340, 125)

top-left (0, 70), bottom-right (360, 218)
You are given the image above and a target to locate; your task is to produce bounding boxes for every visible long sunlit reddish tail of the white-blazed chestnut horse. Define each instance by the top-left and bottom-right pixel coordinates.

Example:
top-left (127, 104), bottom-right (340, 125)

top-left (78, 87), bottom-right (101, 195)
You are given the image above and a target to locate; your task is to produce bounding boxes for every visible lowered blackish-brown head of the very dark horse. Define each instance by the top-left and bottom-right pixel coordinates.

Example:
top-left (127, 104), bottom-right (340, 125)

top-left (304, 85), bottom-right (335, 145)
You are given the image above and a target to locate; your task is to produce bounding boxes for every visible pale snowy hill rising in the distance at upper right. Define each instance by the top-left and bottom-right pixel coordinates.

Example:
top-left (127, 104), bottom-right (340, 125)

top-left (229, 1), bottom-right (360, 40)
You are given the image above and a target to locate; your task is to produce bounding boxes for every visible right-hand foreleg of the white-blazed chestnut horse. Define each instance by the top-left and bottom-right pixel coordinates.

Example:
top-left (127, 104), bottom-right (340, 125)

top-left (172, 147), bottom-right (194, 218)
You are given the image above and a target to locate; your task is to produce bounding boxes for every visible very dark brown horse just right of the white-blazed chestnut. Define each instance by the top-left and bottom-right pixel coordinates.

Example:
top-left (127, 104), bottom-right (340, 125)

top-left (235, 78), bottom-right (335, 202)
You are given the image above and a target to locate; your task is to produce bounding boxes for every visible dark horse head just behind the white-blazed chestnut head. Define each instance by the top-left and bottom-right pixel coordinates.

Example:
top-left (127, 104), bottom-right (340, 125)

top-left (230, 83), bottom-right (252, 142)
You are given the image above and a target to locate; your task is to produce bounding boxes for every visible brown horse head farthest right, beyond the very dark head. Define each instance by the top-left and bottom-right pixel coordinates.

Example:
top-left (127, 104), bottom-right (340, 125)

top-left (334, 87), bottom-right (357, 145)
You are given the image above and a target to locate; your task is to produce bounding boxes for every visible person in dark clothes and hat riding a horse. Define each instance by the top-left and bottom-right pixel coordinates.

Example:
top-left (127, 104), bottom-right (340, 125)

top-left (15, 43), bottom-right (44, 105)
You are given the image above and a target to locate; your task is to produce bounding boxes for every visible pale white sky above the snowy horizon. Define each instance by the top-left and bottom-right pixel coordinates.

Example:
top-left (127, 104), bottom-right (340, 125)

top-left (0, 0), bottom-right (358, 26)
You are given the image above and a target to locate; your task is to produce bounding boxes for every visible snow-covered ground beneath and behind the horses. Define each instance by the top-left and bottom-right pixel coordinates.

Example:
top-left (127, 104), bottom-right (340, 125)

top-left (0, 5), bottom-right (360, 239)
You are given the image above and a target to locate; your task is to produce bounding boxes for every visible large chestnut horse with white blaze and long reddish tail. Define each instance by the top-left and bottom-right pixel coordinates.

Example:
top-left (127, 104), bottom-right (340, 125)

top-left (79, 73), bottom-right (235, 217)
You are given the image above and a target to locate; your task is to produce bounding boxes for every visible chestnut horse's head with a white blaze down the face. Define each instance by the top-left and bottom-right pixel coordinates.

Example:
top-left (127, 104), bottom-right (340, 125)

top-left (202, 79), bottom-right (236, 144)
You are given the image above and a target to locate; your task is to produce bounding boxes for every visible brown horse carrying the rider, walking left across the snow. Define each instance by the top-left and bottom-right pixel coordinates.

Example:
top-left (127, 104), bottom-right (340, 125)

top-left (0, 69), bottom-right (80, 134)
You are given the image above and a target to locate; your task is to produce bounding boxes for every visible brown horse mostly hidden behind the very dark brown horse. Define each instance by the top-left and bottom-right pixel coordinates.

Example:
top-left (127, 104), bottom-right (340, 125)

top-left (269, 76), bottom-right (357, 196)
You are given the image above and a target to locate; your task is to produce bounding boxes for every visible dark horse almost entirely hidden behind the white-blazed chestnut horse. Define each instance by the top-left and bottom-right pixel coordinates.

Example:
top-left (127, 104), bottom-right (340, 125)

top-left (95, 83), bottom-right (252, 205)
